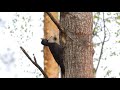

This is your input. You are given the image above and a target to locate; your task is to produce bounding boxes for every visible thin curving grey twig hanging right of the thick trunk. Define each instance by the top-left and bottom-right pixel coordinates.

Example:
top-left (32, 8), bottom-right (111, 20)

top-left (95, 12), bottom-right (106, 72)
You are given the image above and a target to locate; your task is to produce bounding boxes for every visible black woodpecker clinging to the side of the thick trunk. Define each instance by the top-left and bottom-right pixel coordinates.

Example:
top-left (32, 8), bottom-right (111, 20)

top-left (41, 39), bottom-right (65, 75)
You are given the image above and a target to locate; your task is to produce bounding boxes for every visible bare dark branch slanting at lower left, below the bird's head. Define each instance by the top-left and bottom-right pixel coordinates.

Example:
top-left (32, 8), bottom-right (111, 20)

top-left (20, 46), bottom-right (48, 78)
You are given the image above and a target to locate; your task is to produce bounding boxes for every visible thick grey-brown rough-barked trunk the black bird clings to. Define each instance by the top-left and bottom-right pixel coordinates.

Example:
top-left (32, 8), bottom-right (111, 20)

top-left (60, 12), bottom-right (94, 78)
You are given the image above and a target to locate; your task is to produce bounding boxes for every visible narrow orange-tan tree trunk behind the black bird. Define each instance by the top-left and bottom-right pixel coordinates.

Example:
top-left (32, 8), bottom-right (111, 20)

top-left (44, 12), bottom-right (59, 78)
